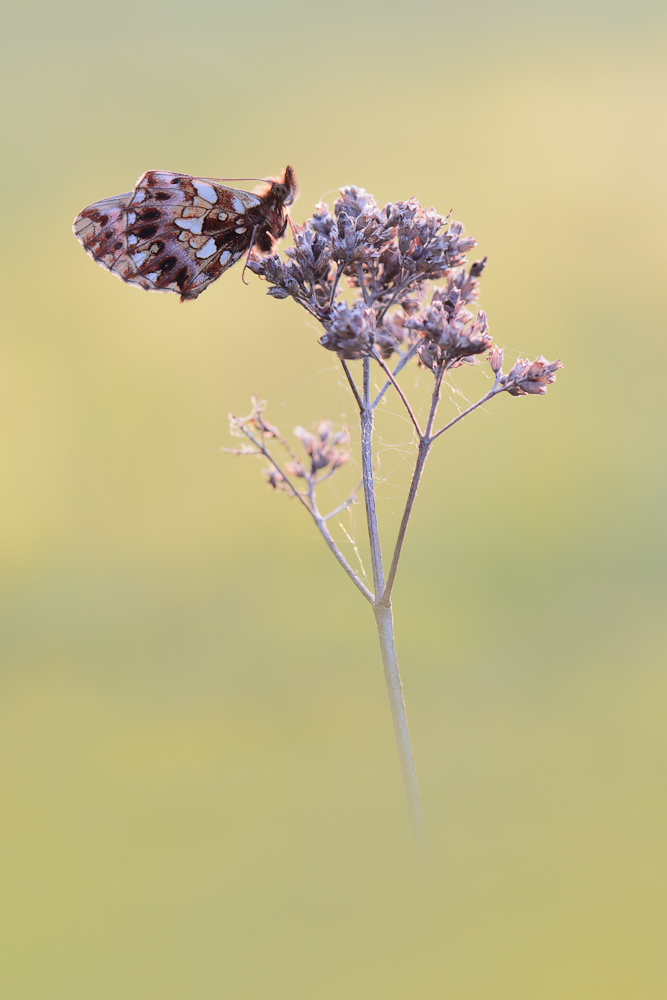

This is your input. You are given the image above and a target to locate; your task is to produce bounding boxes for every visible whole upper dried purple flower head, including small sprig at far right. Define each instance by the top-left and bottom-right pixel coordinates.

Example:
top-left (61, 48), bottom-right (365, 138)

top-left (249, 185), bottom-right (562, 412)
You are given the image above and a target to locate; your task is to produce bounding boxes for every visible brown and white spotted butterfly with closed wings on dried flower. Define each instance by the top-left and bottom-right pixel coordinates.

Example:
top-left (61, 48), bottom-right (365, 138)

top-left (73, 167), bottom-right (298, 302)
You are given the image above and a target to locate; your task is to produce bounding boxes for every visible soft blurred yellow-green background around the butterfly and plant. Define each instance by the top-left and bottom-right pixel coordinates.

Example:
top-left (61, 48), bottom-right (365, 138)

top-left (0, 0), bottom-right (667, 1000)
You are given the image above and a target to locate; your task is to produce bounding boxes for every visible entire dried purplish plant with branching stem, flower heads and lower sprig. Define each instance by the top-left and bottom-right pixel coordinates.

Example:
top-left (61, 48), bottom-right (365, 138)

top-left (224, 187), bottom-right (562, 848)
